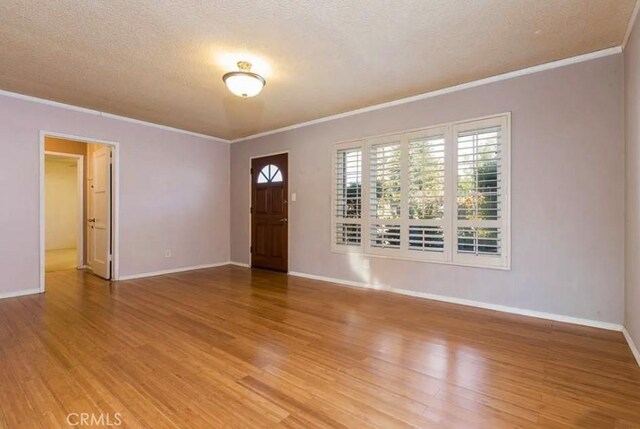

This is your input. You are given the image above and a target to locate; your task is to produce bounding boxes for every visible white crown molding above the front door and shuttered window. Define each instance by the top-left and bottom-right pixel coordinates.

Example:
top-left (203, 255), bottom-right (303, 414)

top-left (231, 46), bottom-right (622, 143)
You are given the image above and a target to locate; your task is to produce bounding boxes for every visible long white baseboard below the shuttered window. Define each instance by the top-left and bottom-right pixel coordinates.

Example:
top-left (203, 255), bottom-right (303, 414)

top-left (289, 271), bottom-right (622, 331)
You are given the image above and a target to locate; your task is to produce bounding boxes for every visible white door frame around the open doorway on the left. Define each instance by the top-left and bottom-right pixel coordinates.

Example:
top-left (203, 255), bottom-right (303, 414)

top-left (38, 130), bottom-right (120, 293)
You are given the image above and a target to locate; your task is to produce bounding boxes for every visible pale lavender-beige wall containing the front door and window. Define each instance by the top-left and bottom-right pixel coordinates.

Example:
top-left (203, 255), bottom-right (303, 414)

top-left (231, 54), bottom-right (624, 324)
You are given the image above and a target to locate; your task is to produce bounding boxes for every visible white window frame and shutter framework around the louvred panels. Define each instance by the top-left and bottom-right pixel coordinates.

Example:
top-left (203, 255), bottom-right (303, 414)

top-left (330, 112), bottom-right (511, 270)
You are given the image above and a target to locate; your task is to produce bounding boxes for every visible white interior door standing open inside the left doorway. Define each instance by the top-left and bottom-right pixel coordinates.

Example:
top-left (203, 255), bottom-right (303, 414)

top-left (88, 146), bottom-right (111, 279)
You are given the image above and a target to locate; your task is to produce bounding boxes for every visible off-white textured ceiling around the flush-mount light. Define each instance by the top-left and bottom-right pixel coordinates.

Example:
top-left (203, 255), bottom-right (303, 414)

top-left (0, 0), bottom-right (635, 139)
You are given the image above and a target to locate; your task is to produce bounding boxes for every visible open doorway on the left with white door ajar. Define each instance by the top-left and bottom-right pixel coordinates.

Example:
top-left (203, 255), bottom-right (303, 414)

top-left (40, 132), bottom-right (118, 292)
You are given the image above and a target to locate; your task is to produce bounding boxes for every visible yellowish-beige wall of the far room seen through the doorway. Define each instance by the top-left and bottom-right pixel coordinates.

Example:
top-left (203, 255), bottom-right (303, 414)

top-left (44, 156), bottom-right (79, 250)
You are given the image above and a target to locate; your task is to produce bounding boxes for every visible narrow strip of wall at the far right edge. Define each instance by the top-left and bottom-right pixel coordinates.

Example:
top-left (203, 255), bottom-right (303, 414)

top-left (624, 13), bottom-right (640, 347)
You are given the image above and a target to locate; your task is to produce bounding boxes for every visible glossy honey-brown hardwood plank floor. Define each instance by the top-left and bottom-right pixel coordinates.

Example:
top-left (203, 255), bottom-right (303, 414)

top-left (0, 266), bottom-right (640, 429)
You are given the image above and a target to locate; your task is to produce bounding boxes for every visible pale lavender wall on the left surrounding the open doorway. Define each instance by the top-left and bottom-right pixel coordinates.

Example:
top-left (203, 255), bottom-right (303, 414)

top-left (0, 95), bottom-right (229, 296)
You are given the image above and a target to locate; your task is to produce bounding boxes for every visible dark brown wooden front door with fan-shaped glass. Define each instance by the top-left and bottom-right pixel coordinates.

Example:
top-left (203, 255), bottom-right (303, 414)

top-left (251, 153), bottom-right (289, 272)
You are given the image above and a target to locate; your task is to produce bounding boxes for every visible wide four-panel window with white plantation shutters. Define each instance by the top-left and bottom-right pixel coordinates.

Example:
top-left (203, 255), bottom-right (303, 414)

top-left (332, 114), bottom-right (510, 268)
